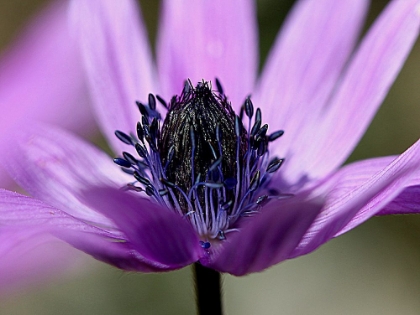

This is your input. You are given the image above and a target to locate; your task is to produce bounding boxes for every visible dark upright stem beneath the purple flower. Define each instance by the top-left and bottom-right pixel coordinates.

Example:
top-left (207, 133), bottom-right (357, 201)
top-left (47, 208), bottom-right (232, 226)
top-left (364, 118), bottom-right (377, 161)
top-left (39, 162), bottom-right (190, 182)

top-left (194, 263), bottom-right (222, 315)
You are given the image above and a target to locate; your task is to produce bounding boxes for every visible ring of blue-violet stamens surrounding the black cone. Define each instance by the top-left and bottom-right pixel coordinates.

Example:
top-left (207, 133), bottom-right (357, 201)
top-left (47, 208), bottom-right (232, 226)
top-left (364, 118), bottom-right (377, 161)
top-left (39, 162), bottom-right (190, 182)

top-left (114, 80), bottom-right (288, 244)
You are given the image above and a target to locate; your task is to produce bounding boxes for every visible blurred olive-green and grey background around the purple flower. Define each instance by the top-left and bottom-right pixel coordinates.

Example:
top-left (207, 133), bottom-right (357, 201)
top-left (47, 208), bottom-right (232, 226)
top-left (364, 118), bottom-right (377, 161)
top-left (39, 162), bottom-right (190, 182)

top-left (0, 0), bottom-right (420, 315)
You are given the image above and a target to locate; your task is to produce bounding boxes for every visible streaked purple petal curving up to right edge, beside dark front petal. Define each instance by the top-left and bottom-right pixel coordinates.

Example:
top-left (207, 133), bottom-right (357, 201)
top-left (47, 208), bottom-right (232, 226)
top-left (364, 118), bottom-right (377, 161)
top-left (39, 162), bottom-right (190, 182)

top-left (292, 141), bottom-right (420, 257)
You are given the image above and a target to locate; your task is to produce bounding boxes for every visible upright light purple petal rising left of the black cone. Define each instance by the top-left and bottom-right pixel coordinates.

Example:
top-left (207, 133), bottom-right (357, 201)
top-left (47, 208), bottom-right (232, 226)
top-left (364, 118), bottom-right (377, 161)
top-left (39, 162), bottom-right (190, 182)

top-left (71, 0), bottom-right (156, 152)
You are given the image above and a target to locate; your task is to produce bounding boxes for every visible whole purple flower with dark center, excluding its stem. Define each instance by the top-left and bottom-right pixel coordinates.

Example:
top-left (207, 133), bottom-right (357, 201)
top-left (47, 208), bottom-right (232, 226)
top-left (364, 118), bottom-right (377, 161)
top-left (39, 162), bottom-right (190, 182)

top-left (0, 0), bottom-right (420, 275)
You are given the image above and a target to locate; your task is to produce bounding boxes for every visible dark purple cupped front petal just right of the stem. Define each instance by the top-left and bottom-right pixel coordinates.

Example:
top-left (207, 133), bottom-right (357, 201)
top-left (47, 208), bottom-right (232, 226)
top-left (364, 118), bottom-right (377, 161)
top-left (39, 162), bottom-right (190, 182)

top-left (201, 197), bottom-right (322, 276)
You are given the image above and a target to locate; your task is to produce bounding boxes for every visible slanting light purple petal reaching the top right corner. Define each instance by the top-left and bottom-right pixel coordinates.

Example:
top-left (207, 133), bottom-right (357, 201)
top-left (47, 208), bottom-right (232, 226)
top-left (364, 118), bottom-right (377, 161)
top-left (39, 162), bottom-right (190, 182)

top-left (287, 0), bottom-right (420, 183)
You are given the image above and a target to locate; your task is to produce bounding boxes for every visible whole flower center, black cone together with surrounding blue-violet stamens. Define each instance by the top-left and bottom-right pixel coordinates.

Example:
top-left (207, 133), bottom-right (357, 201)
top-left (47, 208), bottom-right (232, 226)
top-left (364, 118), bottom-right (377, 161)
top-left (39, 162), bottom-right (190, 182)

top-left (114, 80), bottom-right (284, 243)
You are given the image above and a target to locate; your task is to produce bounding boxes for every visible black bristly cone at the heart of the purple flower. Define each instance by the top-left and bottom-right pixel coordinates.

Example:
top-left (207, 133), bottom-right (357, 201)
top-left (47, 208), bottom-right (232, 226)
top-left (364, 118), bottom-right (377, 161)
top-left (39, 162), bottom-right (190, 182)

top-left (158, 82), bottom-right (247, 211)
